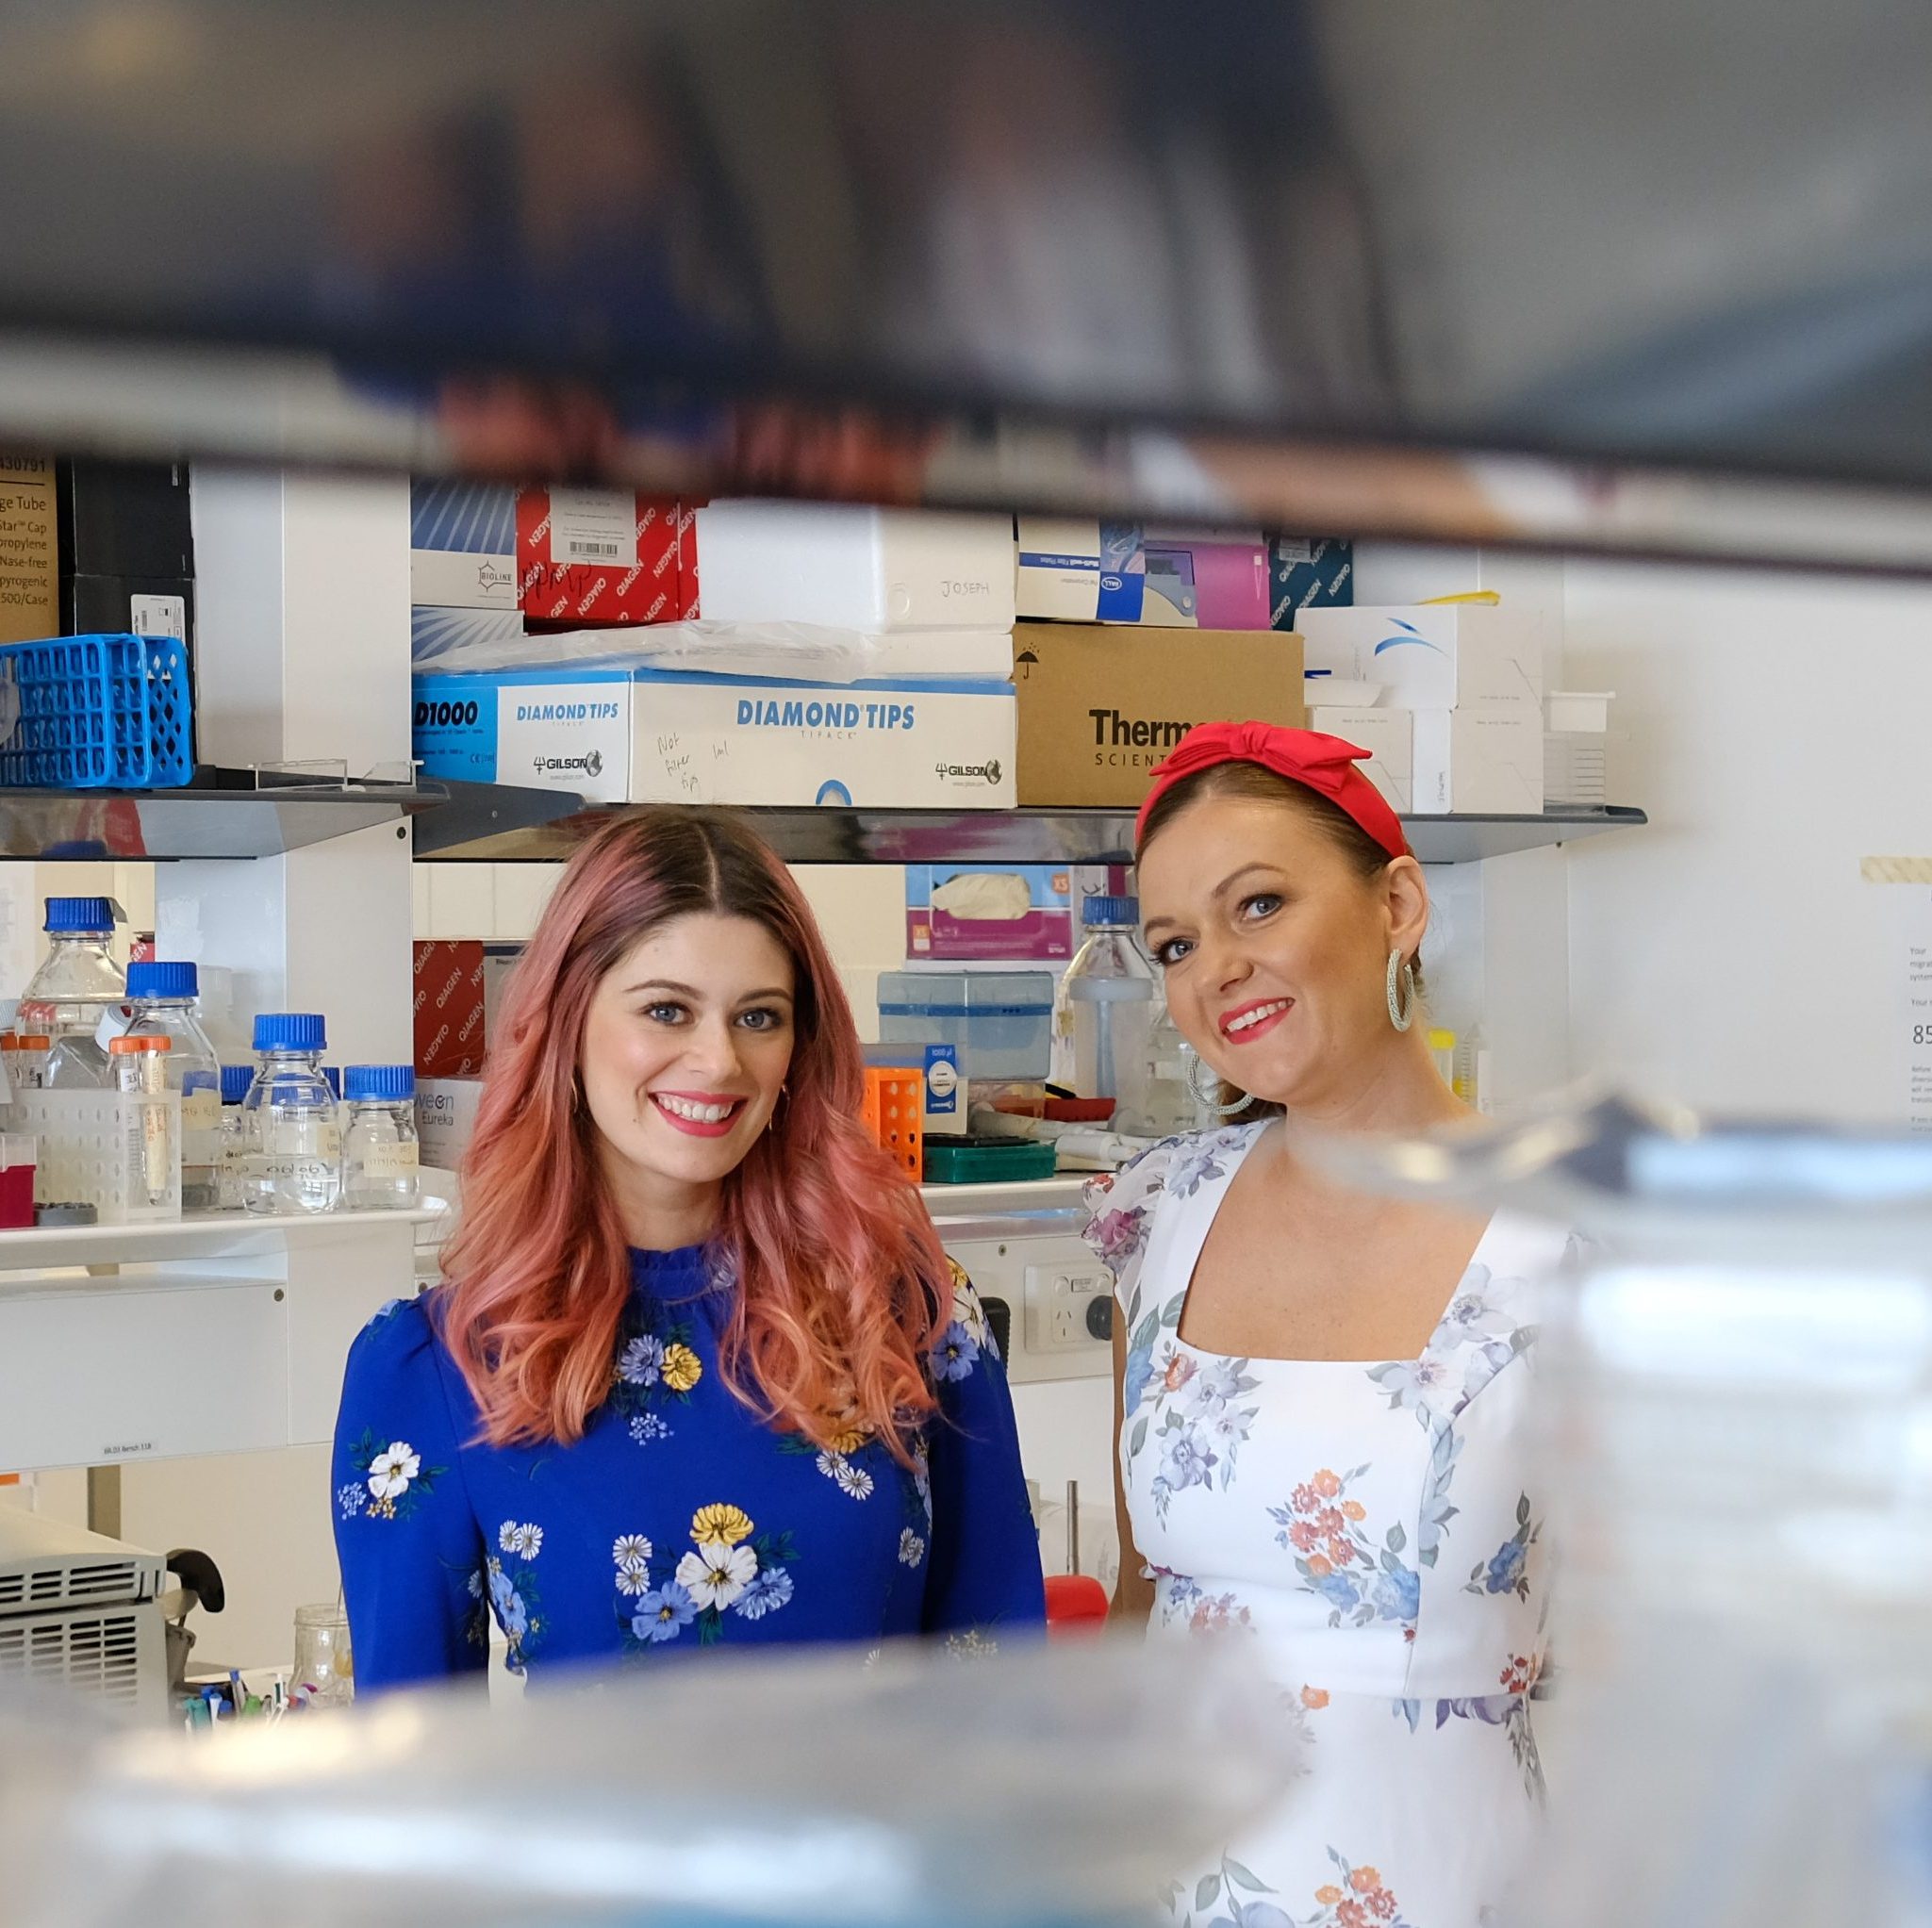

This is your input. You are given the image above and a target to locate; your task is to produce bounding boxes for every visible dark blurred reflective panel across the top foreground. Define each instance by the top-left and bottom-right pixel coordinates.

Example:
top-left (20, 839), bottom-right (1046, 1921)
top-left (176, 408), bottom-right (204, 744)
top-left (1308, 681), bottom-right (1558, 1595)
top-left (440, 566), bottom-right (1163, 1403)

top-left (0, 0), bottom-right (1932, 568)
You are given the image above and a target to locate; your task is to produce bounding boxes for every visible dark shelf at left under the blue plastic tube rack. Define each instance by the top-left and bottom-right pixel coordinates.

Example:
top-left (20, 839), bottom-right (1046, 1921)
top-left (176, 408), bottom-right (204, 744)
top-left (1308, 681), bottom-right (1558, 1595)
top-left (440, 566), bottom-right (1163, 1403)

top-left (0, 766), bottom-right (448, 862)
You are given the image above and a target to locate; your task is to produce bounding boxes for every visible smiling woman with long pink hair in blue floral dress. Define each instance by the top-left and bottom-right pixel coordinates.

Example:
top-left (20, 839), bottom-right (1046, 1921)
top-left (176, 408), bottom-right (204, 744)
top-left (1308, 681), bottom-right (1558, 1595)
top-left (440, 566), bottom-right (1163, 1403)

top-left (334, 810), bottom-right (1043, 1689)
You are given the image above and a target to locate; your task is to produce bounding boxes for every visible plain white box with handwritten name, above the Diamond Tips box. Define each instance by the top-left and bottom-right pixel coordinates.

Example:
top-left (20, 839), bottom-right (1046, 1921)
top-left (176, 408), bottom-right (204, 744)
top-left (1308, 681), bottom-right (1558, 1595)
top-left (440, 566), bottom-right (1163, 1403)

top-left (698, 503), bottom-right (1013, 630)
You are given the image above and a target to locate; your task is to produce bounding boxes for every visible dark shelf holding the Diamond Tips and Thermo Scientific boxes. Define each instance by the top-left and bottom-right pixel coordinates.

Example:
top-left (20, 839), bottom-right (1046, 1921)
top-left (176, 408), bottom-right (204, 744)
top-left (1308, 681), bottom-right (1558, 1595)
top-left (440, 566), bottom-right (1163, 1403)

top-left (416, 784), bottom-right (1648, 864)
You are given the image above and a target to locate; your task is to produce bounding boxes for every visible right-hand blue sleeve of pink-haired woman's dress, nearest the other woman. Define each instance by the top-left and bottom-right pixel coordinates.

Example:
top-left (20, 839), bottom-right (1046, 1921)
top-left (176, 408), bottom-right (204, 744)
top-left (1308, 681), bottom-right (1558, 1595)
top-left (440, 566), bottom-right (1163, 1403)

top-left (921, 1265), bottom-right (1046, 1637)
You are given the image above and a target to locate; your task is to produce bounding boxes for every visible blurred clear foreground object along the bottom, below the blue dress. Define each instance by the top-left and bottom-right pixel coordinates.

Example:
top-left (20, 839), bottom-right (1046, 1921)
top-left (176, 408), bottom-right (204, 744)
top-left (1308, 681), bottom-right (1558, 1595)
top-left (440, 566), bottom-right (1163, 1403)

top-left (0, 1642), bottom-right (1295, 1928)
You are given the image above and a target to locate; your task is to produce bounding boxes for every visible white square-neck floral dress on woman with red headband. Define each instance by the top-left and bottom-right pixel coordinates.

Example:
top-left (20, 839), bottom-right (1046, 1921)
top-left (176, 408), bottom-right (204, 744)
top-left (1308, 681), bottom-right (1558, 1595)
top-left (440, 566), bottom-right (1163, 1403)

top-left (1086, 1125), bottom-right (1563, 1928)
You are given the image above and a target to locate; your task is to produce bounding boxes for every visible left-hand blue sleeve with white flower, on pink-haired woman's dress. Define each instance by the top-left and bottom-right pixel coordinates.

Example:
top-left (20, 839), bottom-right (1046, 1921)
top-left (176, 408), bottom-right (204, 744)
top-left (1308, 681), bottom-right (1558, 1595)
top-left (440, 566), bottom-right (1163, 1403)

top-left (332, 1300), bottom-right (492, 1690)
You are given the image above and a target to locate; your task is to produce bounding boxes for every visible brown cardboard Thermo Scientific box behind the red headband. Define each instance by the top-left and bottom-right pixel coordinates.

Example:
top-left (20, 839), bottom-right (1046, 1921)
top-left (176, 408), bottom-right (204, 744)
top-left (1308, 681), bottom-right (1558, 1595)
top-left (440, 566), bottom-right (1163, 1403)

top-left (1015, 622), bottom-right (1306, 810)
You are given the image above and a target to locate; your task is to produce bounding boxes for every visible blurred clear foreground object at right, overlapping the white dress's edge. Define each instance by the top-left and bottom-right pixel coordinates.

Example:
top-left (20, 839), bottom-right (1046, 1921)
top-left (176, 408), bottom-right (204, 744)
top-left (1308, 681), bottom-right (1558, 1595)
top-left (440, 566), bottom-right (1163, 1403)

top-left (1302, 1097), bottom-right (1932, 1928)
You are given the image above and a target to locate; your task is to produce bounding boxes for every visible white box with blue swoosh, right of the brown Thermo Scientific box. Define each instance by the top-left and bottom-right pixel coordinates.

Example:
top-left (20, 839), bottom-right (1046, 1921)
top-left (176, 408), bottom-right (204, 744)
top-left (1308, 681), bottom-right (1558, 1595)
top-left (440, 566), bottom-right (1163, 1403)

top-left (1300, 602), bottom-right (1544, 715)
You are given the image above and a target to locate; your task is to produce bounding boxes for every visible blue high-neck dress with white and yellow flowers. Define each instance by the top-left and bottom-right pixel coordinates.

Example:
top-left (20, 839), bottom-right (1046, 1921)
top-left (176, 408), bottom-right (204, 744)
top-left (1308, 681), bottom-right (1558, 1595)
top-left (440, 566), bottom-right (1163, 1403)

top-left (334, 1248), bottom-right (1046, 1690)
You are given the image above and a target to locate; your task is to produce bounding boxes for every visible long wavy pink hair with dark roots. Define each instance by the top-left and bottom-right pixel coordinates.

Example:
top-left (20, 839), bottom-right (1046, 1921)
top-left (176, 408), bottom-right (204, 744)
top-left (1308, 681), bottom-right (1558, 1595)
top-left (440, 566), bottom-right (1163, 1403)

top-left (437, 810), bottom-right (952, 1460)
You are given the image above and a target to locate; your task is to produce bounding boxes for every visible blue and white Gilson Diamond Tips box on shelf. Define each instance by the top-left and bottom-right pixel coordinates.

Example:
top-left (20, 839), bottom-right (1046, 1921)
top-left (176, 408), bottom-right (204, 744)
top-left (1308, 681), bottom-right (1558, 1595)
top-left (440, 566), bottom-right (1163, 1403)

top-left (416, 667), bottom-right (1015, 810)
